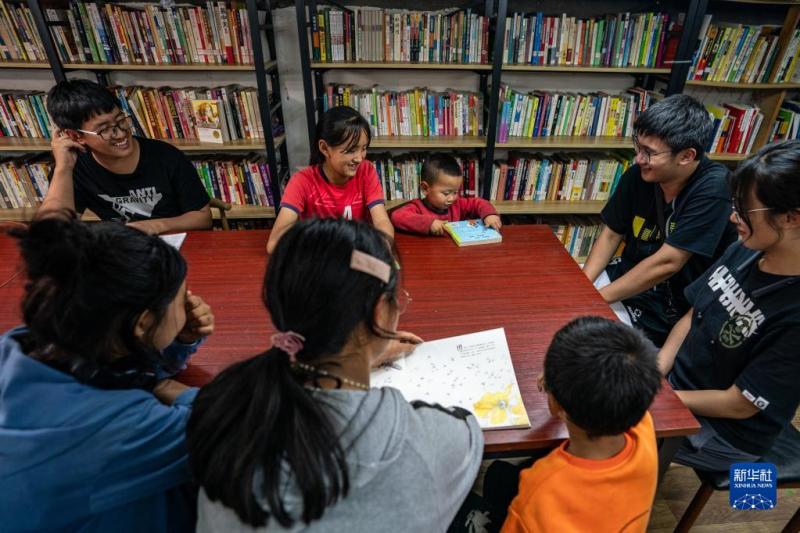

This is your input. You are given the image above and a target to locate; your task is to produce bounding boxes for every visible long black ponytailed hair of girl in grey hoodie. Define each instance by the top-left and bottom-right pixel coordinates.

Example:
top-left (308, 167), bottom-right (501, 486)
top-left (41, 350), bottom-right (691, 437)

top-left (187, 219), bottom-right (398, 527)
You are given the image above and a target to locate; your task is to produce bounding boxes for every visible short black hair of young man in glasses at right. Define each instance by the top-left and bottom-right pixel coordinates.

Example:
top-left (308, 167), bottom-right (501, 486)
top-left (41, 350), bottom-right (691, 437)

top-left (633, 94), bottom-right (714, 159)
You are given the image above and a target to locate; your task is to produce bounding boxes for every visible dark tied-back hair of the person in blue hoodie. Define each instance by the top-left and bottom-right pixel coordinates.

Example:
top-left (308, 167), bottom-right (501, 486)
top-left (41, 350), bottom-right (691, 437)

top-left (9, 211), bottom-right (186, 380)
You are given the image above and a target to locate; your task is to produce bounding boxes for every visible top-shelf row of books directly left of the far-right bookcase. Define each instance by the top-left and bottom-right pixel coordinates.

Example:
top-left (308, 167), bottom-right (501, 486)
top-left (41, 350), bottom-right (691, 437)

top-left (503, 12), bottom-right (674, 67)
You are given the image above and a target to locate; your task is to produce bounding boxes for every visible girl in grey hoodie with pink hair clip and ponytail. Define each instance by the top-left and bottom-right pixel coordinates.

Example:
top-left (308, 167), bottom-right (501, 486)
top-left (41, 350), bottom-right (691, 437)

top-left (187, 219), bottom-right (483, 532)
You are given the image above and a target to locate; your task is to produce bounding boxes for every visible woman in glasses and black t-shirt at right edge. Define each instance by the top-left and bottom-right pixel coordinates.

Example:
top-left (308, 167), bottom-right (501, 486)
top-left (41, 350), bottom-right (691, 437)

top-left (659, 141), bottom-right (800, 471)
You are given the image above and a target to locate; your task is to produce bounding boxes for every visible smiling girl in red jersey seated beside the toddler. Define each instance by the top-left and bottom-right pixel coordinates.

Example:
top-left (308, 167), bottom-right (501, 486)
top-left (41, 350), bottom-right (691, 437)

top-left (267, 106), bottom-right (394, 253)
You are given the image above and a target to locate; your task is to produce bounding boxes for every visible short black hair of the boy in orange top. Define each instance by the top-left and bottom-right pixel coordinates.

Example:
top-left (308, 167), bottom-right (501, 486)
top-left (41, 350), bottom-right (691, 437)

top-left (544, 316), bottom-right (661, 437)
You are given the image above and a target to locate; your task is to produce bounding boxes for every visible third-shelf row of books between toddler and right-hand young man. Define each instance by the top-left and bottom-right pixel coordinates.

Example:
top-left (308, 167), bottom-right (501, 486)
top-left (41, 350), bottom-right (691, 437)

top-left (489, 152), bottom-right (633, 201)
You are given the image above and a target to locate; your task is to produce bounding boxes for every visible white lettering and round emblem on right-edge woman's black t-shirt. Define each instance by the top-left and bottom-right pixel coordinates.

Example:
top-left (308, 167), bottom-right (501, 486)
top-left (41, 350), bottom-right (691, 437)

top-left (708, 265), bottom-right (765, 349)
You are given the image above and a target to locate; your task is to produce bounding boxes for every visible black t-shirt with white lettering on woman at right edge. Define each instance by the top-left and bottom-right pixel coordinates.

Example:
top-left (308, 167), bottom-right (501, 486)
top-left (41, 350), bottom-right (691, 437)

top-left (670, 242), bottom-right (800, 455)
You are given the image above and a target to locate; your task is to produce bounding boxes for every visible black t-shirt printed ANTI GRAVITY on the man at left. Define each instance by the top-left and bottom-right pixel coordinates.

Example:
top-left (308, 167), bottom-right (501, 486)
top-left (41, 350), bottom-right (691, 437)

top-left (61, 137), bottom-right (209, 222)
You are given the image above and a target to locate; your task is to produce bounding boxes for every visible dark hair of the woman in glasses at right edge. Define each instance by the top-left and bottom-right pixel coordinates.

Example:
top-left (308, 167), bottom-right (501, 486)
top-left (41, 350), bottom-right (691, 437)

top-left (730, 140), bottom-right (800, 232)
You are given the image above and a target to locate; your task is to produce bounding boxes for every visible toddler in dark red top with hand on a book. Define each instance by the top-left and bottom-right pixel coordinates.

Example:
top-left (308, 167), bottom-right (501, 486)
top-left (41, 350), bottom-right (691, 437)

top-left (392, 154), bottom-right (502, 235)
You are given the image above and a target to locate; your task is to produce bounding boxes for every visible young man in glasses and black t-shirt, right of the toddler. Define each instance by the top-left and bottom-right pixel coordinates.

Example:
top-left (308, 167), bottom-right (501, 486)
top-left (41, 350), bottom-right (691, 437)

top-left (583, 95), bottom-right (736, 346)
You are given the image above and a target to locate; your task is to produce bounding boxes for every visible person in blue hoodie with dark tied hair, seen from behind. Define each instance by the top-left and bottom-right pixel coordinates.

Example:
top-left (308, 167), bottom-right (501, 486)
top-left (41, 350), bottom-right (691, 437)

top-left (0, 212), bottom-right (214, 532)
